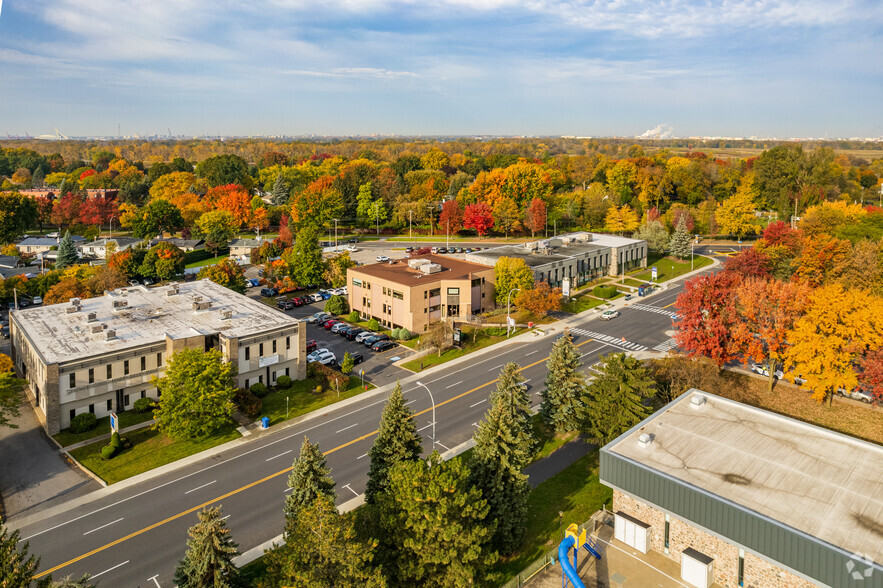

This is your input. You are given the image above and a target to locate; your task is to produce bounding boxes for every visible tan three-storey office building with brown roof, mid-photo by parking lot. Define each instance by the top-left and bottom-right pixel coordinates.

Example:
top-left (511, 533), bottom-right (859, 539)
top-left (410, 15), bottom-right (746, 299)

top-left (347, 255), bottom-right (494, 333)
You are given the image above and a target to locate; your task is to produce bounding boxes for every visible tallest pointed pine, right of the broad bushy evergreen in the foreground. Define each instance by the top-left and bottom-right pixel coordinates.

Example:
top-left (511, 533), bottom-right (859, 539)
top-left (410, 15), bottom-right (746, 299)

top-left (470, 363), bottom-right (537, 553)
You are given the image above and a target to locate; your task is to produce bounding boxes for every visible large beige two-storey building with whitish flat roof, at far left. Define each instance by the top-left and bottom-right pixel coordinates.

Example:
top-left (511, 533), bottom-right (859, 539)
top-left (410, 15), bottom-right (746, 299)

top-left (9, 280), bottom-right (306, 435)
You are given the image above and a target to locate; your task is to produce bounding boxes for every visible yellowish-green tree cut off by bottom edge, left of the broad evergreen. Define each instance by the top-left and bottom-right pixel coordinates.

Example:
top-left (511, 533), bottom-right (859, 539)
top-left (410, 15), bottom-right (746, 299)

top-left (265, 496), bottom-right (385, 588)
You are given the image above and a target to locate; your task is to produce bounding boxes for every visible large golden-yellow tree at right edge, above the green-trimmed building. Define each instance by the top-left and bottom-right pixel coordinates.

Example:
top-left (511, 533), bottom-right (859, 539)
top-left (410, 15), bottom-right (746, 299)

top-left (786, 284), bottom-right (883, 404)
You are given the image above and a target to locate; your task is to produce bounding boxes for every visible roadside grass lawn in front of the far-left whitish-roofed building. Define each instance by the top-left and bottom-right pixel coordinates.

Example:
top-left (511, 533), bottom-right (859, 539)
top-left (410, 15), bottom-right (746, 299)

top-left (71, 423), bottom-right (240, 484)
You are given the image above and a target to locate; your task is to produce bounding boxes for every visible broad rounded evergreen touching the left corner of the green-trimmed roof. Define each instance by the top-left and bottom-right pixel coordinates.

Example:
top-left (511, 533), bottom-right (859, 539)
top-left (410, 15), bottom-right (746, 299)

top-left (583, 353), bottom-right (653, 446)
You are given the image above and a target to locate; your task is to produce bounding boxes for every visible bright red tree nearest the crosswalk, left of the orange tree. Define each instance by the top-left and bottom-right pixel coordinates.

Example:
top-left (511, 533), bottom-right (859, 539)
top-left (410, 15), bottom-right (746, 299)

top-left (674, 272), bottom-right (738, 365)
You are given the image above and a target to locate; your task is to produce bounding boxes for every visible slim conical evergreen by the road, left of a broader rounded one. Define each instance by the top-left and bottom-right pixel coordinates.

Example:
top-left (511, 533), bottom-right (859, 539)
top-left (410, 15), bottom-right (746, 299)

top-left (540, 332), bottom-right (586, 432)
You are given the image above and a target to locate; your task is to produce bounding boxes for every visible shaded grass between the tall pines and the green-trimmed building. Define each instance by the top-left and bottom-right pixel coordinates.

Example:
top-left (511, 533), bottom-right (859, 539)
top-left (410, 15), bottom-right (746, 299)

top-left (491, 451), bottom-right (613, 585)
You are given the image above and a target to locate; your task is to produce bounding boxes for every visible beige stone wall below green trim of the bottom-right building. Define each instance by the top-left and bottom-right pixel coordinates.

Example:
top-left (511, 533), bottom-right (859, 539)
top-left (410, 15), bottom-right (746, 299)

top-left (613, 490), bottom-right (816, 588)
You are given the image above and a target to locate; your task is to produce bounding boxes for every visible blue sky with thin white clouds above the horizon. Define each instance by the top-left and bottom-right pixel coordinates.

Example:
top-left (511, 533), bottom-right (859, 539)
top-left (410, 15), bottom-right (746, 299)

top-left (0, 0), bottom-right (883, 137)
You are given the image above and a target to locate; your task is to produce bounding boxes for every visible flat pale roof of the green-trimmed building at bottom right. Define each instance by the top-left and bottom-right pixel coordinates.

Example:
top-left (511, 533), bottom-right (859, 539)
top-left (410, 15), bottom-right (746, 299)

top-left (605, 390), bottom-right (883, 562)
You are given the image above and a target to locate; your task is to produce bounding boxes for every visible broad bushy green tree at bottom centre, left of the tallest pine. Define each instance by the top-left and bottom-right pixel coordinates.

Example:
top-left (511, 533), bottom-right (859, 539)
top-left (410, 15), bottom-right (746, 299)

top-left (377, 451), bottom-right (497, 588)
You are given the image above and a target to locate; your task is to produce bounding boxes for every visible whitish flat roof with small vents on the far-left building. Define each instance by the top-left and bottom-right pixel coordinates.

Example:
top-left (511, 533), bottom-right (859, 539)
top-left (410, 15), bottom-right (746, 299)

top-left (11, 279), bottom-right (297, 364)
